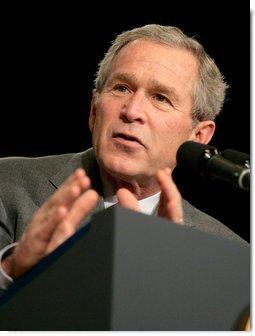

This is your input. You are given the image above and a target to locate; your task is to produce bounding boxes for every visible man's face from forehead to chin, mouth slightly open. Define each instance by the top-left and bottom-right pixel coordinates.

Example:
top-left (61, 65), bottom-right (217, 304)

top-left (89, 41), bottom-right (203, 185)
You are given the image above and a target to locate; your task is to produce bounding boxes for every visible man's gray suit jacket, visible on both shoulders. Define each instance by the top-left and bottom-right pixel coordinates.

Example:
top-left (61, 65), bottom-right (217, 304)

top-left (0, 149), bottom-right (246, 250)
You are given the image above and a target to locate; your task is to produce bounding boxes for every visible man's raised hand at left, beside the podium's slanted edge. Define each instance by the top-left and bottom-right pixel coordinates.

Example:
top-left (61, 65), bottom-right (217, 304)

top-left (2, 169), bottom-right (98, 278)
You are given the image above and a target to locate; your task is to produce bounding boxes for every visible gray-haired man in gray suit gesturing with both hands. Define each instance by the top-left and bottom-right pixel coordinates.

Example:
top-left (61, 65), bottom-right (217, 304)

top-left (0, 25), bottom-right (245, 288)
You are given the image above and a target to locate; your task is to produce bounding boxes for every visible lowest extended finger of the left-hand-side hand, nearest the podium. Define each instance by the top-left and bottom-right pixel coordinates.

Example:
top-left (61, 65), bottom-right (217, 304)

top-left (47, 189), bottom-right (99, 253)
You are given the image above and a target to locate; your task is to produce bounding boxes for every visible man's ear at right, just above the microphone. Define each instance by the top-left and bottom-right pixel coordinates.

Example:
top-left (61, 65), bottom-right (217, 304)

top-left (190, 120), bottom-right (216, 144)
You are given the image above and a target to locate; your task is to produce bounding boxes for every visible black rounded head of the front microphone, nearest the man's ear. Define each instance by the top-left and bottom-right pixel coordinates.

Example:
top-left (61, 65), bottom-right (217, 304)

top-left (176, 141), bottom-right (219, 175)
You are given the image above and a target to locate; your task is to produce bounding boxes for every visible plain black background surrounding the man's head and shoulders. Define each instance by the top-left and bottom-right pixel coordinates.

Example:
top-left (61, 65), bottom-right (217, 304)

top-left (0, 1), bottom-right (250, 241)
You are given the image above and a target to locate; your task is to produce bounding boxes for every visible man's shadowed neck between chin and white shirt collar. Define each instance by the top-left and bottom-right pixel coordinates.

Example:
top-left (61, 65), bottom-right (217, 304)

top-left (100, 169), bottom-right (160, 200)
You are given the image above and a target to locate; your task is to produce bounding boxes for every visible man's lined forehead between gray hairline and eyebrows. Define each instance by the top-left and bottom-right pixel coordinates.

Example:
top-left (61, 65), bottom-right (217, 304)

top-left (107, 40), bottom-right (198, 98)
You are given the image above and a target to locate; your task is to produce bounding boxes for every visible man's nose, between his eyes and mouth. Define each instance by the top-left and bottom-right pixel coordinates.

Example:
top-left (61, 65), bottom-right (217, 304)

top-left (121, 91), bottom-right (146, 124)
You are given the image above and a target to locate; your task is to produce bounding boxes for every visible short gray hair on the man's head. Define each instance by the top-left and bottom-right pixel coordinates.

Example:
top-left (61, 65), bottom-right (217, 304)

top-left (94, 24), bottom-right (228, 122)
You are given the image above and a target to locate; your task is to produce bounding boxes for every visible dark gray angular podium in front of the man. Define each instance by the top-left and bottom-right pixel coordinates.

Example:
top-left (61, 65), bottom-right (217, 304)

top-left (0, 206), bottom-right (250, 331)
